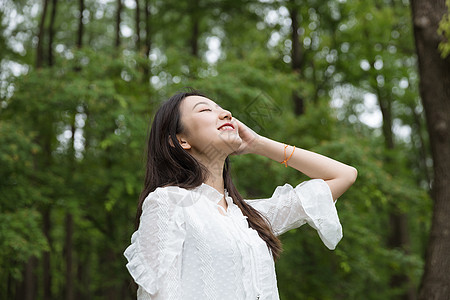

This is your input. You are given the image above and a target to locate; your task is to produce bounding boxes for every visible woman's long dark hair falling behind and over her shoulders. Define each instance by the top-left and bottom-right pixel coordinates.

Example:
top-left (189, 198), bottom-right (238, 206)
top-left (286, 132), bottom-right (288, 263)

top-left (136, 91), bottom-right (282, 259)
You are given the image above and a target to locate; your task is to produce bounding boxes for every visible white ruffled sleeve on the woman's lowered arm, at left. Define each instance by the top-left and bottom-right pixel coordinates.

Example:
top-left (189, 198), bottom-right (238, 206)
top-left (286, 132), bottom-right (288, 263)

top-left (124, 188), bottom-right (186, 300)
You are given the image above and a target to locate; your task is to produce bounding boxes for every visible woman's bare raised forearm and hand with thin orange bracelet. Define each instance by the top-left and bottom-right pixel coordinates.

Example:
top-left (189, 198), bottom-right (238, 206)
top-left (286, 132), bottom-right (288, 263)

top-left (237, 121), bottom-right (358, 200)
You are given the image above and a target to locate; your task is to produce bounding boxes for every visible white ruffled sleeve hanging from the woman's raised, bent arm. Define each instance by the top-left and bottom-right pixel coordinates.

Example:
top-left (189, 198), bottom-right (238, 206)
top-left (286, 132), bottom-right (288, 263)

top-left (245, 179), bottom-right (342, 250)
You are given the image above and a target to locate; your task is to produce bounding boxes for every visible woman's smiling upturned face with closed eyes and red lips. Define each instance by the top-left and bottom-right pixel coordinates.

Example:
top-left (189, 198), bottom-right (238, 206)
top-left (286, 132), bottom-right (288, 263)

top-left (177, 96), bottom-right (242, 160)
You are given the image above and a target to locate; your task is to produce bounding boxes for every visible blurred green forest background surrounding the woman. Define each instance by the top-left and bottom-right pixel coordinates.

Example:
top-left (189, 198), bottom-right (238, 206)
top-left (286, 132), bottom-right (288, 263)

top-left (0, 0), bottom-right (450, 300)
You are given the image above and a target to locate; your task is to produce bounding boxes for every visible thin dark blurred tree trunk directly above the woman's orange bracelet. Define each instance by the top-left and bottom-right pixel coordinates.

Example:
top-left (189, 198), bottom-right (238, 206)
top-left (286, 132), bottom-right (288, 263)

top-left (289, 0), bottom-right (305, 116)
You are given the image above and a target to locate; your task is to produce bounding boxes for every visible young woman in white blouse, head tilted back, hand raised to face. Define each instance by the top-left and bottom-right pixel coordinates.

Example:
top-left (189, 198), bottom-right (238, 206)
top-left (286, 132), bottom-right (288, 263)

top-left (124, 92), bottom-right (357, 300)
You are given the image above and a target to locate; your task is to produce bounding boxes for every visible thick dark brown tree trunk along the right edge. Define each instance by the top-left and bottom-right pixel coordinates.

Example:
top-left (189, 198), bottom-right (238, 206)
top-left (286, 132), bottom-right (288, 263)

top-left (411, 0), bottom-right (450, 300)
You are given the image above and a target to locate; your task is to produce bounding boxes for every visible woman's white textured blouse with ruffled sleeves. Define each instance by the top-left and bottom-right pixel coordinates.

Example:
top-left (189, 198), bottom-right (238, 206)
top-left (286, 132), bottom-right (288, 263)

top-left (124, 179), bottom-right (342, 300)
